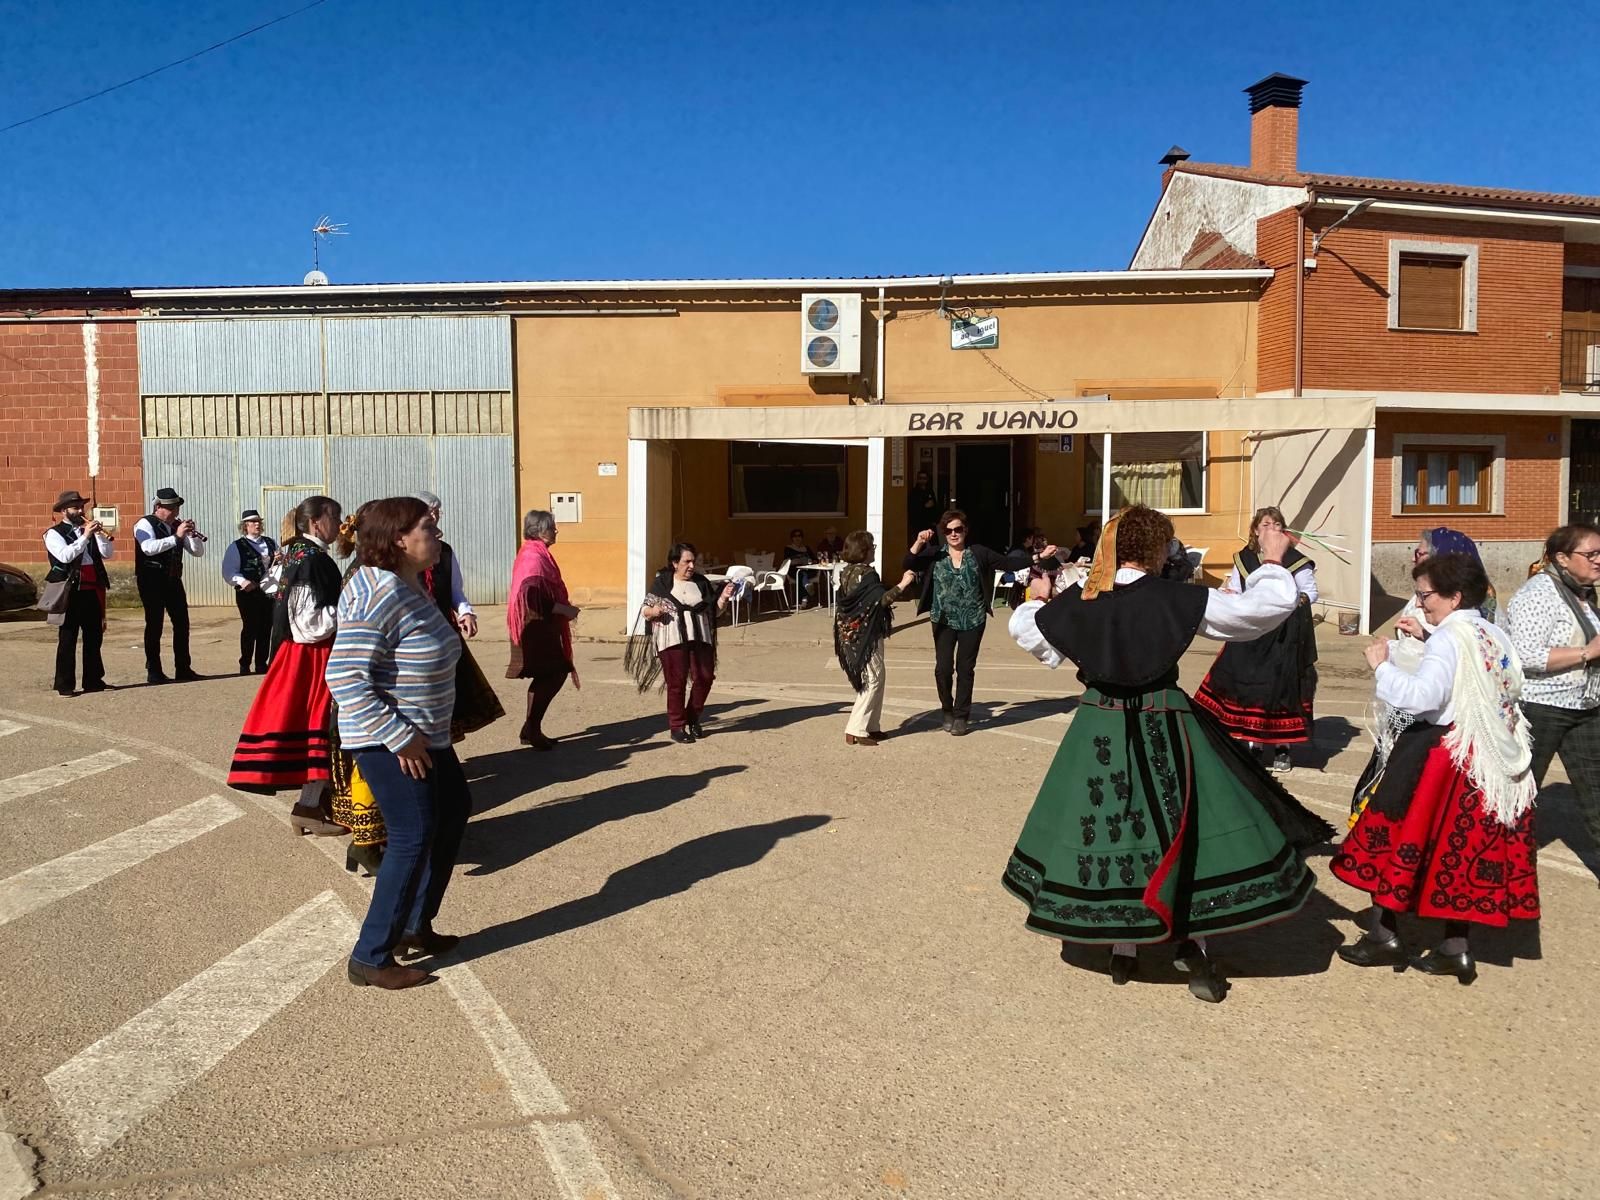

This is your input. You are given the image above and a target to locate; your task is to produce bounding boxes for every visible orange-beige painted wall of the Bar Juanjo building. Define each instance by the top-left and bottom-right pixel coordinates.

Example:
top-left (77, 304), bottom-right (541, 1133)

top-left (515, 280), bottom-right (1256, 603)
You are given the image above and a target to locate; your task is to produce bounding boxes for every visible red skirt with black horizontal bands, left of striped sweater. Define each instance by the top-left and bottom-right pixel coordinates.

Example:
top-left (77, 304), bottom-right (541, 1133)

top-left (227, 640), bottom-right (333, 792)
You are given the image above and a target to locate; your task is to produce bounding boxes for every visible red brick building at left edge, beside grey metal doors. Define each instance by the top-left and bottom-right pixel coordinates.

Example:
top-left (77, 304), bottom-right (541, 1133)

top-left (0, 296), bottom-right (146, 578)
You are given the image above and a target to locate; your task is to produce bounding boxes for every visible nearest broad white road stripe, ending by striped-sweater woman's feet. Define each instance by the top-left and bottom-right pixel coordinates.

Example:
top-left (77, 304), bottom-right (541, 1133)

top-left (45, 891), bottom-right (355, 1158)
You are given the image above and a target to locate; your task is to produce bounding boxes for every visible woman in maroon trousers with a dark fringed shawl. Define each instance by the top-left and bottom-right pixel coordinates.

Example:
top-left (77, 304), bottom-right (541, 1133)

top-left (624, 542), bottom-right (734, 742)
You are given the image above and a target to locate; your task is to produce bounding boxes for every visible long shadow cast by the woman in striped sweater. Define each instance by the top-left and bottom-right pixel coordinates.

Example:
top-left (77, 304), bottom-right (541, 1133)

top-left (451, 813), bottom-right (834, 962)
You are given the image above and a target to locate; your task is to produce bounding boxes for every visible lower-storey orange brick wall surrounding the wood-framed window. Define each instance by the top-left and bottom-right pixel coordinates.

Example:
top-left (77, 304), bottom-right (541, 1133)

top-left (1373, 413), bottom-right (1562, 542)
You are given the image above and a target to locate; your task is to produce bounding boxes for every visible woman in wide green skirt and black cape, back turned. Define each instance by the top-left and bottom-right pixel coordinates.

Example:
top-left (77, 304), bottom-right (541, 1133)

top-left (1003, 506), bottom-right (1333, 1003)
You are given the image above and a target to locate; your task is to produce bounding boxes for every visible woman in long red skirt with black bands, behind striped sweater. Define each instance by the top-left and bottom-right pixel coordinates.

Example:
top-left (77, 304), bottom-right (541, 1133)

top-left (227, 496), bottom-right (344, 837)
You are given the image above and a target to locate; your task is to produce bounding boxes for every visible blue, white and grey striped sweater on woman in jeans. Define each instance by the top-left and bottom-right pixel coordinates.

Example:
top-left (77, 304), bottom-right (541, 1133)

top-left (326, 566), bottom-right (461, 750)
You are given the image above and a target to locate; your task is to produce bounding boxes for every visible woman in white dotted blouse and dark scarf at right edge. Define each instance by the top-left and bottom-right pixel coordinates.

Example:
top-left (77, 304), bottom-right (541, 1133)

top-left (1506, 525), bottom-right (1600, 870)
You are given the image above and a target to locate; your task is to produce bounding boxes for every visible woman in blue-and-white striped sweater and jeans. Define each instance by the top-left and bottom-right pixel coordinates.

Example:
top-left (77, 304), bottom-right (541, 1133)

top-left (328, 496), bottom-right (470, 989)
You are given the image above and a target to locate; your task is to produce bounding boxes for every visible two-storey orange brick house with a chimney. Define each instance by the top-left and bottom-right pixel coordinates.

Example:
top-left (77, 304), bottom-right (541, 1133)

top-left (1133, 75), bottom-right (1600, 611)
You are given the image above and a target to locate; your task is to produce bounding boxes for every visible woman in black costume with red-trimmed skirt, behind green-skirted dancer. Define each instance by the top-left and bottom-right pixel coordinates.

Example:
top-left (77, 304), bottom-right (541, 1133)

top-left (1195, 507), bottom-right (1317, 774)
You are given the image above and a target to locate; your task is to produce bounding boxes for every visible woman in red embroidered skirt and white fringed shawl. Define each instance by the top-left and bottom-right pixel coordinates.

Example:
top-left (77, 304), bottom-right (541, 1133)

top-left (1330, 554), bottom-right (1539, 984)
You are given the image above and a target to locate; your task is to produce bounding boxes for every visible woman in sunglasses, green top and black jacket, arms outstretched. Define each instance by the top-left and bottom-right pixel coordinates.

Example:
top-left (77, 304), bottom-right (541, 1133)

top-left (901, 509), bottom-right (1056, 738)
